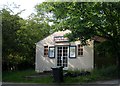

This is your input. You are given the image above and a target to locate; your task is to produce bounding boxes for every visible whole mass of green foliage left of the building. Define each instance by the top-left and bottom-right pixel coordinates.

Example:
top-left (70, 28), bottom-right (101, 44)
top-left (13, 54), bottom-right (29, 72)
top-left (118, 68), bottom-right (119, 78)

top-left (1, 9), bottom-right (50, 70)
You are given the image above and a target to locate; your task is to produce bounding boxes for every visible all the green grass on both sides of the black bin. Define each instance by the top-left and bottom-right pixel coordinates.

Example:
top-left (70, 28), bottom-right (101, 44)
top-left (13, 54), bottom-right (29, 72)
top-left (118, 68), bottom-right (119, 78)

top-left (2, 66), bottom-right (117, 83)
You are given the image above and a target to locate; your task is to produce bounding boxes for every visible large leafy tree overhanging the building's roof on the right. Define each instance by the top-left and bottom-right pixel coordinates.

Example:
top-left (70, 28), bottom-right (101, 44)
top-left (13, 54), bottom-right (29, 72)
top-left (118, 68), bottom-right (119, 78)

top-left (37, 2), bottom-right (120, 77)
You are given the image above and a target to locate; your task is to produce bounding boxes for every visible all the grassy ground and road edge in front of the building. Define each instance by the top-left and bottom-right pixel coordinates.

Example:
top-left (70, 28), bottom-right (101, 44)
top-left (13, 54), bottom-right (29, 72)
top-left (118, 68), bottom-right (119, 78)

top-left (2, 67), bottom-right (120, 86)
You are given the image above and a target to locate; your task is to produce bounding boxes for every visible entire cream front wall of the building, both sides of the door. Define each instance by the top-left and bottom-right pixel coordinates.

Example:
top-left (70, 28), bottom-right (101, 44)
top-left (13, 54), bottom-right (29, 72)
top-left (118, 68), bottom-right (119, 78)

top-left (35, 32), bottom-right (94, 72)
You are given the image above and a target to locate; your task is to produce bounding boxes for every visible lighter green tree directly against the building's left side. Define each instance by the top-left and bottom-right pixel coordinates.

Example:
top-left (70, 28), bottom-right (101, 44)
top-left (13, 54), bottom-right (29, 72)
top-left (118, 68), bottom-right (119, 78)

top-left (17, 14), bottom-right (50, 67)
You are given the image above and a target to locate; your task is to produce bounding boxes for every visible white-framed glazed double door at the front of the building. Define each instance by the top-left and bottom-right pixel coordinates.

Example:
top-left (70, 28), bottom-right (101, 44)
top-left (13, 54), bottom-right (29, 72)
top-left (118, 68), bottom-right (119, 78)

top-left (57, 46), bottom-right (69, 68)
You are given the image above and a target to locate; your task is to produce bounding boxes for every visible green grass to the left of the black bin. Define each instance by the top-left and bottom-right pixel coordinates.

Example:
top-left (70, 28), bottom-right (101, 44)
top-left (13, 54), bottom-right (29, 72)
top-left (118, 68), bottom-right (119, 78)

top-left (2, 70), bottom-right (53, 83)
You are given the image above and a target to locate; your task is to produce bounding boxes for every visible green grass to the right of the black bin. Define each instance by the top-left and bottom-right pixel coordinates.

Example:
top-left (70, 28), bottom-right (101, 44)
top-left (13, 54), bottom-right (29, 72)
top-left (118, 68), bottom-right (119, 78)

top-left (65, 65), bottom-right (118, 83)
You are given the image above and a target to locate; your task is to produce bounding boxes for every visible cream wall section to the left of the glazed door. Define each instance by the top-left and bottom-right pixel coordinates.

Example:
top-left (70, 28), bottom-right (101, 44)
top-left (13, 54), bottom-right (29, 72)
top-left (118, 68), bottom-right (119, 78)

top-left (35, 36), bottom-right (55, 72)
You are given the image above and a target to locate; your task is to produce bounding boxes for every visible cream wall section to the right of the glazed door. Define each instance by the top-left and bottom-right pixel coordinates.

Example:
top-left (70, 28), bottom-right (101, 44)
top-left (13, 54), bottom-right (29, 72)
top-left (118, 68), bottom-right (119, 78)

top-left (68, 41), bottom-right (94, 70)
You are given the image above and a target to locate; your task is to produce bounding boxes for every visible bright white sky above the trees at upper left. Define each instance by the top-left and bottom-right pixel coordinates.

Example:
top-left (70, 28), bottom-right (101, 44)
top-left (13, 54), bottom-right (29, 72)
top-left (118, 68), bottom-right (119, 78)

top-left (0, 0), bottom-right (45, 19)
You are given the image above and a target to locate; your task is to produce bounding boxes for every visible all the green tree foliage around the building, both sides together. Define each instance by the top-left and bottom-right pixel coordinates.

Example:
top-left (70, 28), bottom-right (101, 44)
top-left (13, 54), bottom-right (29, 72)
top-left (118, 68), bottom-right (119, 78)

top-left (1, 2), bottom-right (120, 70)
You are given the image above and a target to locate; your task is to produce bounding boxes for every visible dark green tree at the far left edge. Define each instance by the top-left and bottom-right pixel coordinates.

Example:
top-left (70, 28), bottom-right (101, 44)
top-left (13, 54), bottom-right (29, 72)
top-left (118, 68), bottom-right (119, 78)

top-left (1, 9), bottom-right (21, 68)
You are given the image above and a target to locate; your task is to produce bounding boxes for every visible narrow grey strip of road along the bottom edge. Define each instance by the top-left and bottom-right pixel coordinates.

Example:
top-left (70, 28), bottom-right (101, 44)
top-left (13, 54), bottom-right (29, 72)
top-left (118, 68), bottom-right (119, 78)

top-left (2, 80), bottom-right (120, 86)
